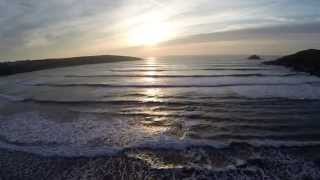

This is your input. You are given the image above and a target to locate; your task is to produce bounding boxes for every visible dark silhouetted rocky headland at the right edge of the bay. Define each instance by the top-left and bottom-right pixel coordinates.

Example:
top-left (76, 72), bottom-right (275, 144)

top-left (265, 49), bottom-right (320, 76)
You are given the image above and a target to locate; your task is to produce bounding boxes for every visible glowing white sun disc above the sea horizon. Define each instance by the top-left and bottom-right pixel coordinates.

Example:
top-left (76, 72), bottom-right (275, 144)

top-left (128, 21), bottom-right (173, 46)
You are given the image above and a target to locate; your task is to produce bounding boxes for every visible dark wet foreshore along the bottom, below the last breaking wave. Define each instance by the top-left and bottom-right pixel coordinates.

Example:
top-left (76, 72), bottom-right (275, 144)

top-left (0, 143), bottom-right (320, 179)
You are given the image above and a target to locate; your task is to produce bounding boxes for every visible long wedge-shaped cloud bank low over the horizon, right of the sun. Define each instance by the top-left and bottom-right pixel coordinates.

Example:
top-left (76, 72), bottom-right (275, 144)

top-left (117, 23), bottom-right (320, 56)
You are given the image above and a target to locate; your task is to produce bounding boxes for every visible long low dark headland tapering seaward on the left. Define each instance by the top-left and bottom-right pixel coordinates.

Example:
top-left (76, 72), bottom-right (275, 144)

top-left (0, 55), bottom-right (140, 76)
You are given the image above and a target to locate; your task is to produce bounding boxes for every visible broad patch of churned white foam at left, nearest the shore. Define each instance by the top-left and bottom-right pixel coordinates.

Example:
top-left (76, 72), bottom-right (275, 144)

top-left (0, 112), bottom-right (178, 156)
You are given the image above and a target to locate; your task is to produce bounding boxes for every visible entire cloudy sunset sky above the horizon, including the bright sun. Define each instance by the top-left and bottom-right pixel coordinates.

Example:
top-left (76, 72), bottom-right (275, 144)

top-left (0, 0), bottom-right (320, 61)
